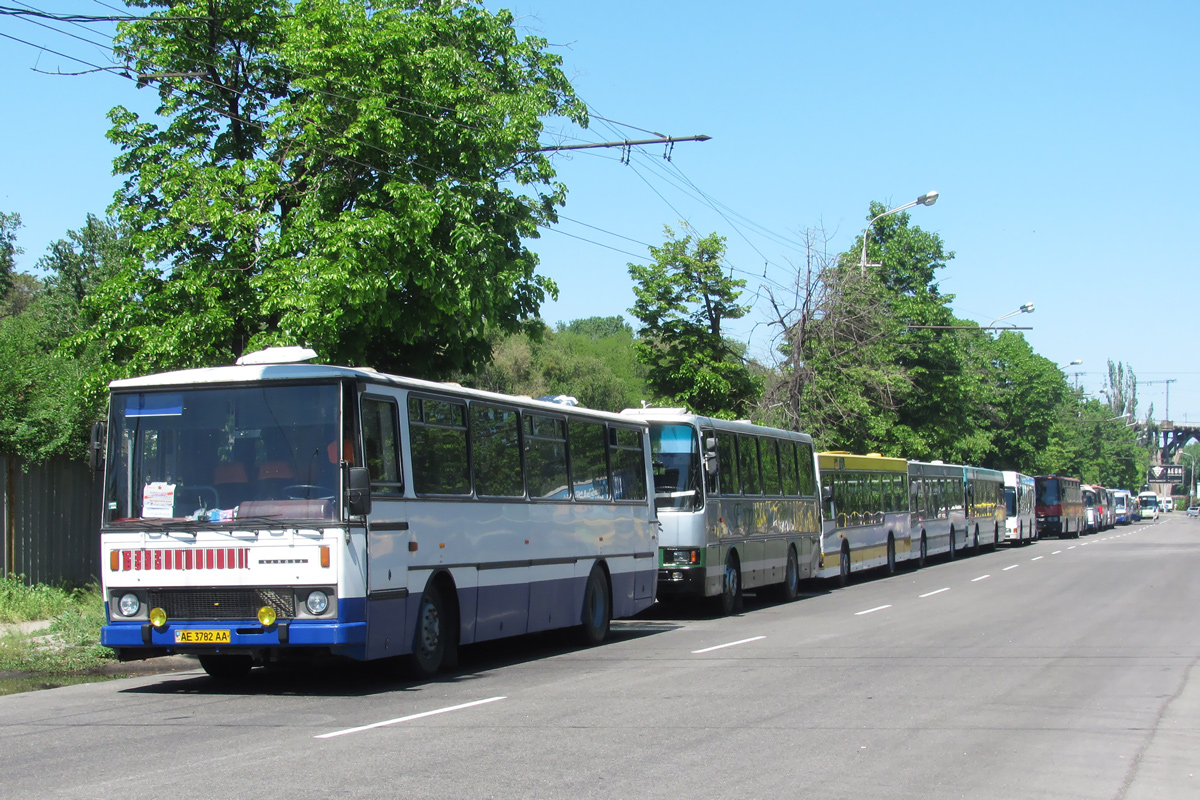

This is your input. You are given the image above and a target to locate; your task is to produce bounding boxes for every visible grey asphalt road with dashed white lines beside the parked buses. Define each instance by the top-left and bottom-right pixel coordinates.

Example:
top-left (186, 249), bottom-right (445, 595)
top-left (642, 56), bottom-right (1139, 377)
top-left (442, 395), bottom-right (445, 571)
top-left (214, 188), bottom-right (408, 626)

top-left (0, 513), bottom-right (1200, 800)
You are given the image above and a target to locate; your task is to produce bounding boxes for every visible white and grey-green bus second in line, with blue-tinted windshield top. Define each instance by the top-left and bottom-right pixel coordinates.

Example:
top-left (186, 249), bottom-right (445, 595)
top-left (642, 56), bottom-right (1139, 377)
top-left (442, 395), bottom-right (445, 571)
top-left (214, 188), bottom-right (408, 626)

top-left (622, 408), bottom-right (821, 614)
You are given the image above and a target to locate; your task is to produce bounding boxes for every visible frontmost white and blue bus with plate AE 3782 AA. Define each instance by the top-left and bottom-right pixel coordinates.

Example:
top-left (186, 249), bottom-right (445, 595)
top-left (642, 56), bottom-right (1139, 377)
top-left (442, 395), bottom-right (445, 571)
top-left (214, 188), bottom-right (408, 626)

top-left (92, 348), bottom-right (658, 676)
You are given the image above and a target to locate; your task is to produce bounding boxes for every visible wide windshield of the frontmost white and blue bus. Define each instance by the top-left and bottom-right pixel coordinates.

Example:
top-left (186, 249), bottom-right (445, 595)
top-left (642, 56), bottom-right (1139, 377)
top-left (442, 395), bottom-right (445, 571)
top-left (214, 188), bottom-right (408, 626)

top-left (104, 384), bottom-right (341, 527)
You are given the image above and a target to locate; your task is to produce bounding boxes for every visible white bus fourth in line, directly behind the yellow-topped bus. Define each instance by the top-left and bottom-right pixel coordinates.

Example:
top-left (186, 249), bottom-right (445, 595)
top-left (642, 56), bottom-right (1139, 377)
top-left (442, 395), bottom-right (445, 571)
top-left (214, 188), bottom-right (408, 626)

top-left (908, 461), bottom-right (967, 566)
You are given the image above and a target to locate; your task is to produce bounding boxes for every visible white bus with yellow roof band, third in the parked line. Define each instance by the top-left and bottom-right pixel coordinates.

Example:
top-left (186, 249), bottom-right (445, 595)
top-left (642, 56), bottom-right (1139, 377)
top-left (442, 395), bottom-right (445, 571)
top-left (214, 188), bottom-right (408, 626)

top-left (817, 451), bottom-right (913, 583)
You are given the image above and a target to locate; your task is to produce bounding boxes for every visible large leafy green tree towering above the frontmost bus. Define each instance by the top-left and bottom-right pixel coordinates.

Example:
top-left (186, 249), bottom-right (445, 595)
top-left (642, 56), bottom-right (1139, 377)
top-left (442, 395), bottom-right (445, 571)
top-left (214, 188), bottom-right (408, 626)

top-left (79, 0), bottom-right (586, 377)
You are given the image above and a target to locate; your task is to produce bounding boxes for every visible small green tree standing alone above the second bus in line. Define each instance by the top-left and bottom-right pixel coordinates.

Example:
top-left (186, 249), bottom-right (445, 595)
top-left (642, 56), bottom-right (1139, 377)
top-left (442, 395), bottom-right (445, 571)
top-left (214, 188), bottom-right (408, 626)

top-left (629, 228), bottom-right (762, 416)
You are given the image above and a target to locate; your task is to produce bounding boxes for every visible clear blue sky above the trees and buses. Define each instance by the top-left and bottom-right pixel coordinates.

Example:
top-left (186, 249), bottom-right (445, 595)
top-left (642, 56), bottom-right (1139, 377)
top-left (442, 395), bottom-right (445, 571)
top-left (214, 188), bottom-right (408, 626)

top-left (0, 0), bottom-right (1200, 422)
